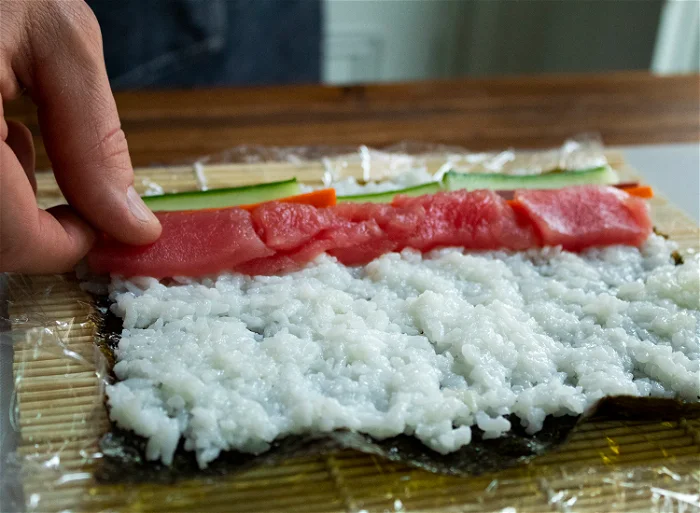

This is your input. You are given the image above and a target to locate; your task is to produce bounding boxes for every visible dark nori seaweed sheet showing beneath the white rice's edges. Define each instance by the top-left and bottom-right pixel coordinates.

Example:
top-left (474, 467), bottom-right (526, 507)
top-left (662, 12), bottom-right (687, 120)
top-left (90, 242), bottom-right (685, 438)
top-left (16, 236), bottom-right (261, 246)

top-left (90, 296), bottom-right (700, 484)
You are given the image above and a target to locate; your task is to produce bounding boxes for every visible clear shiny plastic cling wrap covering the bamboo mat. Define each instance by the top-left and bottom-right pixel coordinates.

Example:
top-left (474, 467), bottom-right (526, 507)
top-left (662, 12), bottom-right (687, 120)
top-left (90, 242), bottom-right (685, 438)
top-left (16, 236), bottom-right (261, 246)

top-left (0, 137), bottom-right (700, 513)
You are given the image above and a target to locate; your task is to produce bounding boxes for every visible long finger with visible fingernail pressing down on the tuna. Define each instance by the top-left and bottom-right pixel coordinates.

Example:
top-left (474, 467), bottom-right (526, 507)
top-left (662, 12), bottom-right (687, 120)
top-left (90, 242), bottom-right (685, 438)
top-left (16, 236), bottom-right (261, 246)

top-left (20, 0), bottom-right (161, 244)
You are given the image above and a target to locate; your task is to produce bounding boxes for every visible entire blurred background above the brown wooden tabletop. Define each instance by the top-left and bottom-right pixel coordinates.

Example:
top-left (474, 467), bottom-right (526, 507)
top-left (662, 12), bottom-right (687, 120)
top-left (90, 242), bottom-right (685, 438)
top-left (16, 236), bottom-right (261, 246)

top-left (88, 0), bottom-right (700, 90)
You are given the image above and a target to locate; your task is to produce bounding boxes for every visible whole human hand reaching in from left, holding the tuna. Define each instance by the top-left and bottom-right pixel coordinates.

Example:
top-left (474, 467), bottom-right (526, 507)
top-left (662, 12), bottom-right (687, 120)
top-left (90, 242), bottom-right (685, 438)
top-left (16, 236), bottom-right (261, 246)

top-left (0, 0), bottom-right (161, 273)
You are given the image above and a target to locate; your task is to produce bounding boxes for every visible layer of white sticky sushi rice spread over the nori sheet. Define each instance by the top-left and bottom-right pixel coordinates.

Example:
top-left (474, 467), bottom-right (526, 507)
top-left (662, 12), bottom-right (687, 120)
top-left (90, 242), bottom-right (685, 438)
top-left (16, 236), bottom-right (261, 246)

top-left (107, 235), bottom-right (700, 467)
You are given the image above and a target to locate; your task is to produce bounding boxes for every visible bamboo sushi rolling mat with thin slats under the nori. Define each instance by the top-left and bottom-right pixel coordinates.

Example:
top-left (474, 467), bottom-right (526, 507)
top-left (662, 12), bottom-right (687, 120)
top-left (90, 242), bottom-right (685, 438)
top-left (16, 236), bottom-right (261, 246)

top-left (10, 153), bottom-right (700, 513)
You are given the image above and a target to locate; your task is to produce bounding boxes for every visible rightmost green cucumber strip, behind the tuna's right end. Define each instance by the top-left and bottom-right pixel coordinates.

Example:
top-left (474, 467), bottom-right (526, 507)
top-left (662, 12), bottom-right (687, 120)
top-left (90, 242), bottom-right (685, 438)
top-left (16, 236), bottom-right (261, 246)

top-left (444, 166), bottom-right (617, 191)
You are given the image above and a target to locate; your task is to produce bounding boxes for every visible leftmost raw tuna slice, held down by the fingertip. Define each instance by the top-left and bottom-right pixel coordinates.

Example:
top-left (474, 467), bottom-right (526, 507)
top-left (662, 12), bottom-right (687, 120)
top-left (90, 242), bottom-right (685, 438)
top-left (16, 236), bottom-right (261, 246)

top-left (88, 208), bottom-right (275, 278)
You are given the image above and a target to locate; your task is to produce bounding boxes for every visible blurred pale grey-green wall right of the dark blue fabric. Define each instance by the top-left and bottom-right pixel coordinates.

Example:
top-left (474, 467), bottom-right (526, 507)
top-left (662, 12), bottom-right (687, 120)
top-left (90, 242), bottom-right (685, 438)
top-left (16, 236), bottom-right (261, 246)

top-left (322, 0), bottom-right (668, 84)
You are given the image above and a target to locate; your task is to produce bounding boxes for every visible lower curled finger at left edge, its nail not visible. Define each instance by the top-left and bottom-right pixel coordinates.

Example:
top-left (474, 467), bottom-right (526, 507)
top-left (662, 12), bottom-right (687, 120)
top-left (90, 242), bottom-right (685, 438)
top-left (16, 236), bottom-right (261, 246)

top-left (0, 141), bottom-right (95, 273)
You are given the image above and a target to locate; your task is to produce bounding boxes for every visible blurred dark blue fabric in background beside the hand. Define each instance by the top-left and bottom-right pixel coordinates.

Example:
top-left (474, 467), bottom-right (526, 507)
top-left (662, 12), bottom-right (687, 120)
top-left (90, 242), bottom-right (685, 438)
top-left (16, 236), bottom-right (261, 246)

top-left (88, 0), bottom-right (321, 90)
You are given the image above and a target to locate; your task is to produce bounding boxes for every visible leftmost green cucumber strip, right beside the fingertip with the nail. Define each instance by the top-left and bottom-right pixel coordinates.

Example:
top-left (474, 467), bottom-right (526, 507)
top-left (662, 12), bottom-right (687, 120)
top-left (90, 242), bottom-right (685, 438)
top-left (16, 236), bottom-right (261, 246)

top-left (143, 178), bottom-right (300, 211)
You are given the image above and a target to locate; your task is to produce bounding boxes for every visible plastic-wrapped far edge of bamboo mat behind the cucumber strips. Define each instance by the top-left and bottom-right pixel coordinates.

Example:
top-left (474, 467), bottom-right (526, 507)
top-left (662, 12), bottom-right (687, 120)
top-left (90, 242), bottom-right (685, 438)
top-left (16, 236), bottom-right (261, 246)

top-left (30, 135), bottom-right (608, 208)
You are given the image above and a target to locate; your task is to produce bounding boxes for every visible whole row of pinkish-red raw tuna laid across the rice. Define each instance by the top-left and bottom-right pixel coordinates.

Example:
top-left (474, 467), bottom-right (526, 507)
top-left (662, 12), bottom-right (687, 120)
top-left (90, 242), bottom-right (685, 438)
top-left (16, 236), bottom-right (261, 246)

top-left (88, 186), bottom-right (651, 278)
